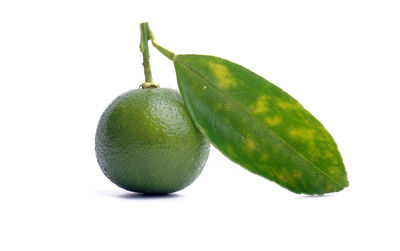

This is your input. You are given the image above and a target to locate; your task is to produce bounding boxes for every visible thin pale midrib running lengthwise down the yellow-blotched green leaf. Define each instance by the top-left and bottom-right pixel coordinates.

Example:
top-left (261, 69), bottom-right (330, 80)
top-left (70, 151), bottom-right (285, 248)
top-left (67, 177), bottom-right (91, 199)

top-left (174, 55), bottom-right (346, 188)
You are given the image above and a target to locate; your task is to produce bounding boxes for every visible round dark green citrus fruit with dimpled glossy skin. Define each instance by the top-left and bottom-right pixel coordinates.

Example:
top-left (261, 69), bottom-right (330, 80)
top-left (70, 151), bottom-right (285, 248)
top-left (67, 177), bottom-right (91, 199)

top-left (95, 88), bottom-right (210, 194)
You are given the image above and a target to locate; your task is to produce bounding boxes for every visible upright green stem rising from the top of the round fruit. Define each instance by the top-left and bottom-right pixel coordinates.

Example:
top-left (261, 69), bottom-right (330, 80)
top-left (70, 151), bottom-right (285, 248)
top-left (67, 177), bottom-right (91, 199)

top-left (139, 22), bottom-right (153, 83)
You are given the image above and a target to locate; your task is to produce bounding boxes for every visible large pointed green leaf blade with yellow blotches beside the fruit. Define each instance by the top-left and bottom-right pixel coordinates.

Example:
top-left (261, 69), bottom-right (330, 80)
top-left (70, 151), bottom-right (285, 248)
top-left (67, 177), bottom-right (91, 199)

top-left (172, 55), bottom-right (348, 194)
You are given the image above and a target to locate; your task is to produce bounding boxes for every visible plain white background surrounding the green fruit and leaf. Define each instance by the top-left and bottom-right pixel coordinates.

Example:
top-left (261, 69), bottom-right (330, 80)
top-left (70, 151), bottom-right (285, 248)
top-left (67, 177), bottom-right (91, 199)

top-left (0, 0), bottom-right (400, 250)
